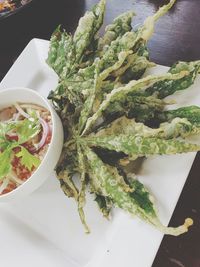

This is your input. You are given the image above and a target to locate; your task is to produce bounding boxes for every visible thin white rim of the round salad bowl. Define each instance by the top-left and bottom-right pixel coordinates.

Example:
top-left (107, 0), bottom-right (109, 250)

top-left (0, 87), bottom-right (61, 201)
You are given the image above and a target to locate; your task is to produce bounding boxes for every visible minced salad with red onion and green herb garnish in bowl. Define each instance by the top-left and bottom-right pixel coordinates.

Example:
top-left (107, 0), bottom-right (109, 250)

top-left (0, 103), bottom-right (52, 195)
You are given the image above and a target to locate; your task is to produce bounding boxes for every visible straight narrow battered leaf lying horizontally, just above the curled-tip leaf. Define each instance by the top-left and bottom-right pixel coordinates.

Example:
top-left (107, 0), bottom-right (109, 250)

top-left (84, 134), bottom-right (200, 157)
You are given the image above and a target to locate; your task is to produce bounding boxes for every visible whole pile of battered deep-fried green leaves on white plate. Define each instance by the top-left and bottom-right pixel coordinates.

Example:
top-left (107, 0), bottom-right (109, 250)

top-left (47, 0), bottom-right (200, 235)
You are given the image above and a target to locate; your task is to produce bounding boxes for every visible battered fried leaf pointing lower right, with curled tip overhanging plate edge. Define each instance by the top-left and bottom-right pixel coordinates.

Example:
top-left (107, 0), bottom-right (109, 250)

top-left (85, 148), bottom-right (191, 235)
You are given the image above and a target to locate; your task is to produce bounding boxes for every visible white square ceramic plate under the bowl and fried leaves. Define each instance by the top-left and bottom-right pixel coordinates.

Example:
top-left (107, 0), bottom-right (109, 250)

top-left (0, 39), bottom-right (200, 267)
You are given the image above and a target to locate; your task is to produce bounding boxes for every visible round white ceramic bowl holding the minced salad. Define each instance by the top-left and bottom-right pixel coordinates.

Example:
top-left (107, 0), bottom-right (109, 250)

top-left (0, 88), bottom-right (63, 202)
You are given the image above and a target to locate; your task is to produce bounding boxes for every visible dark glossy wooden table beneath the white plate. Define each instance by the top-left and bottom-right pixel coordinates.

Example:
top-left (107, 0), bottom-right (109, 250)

top-left (0, 0), bottom-right (200, 267)
